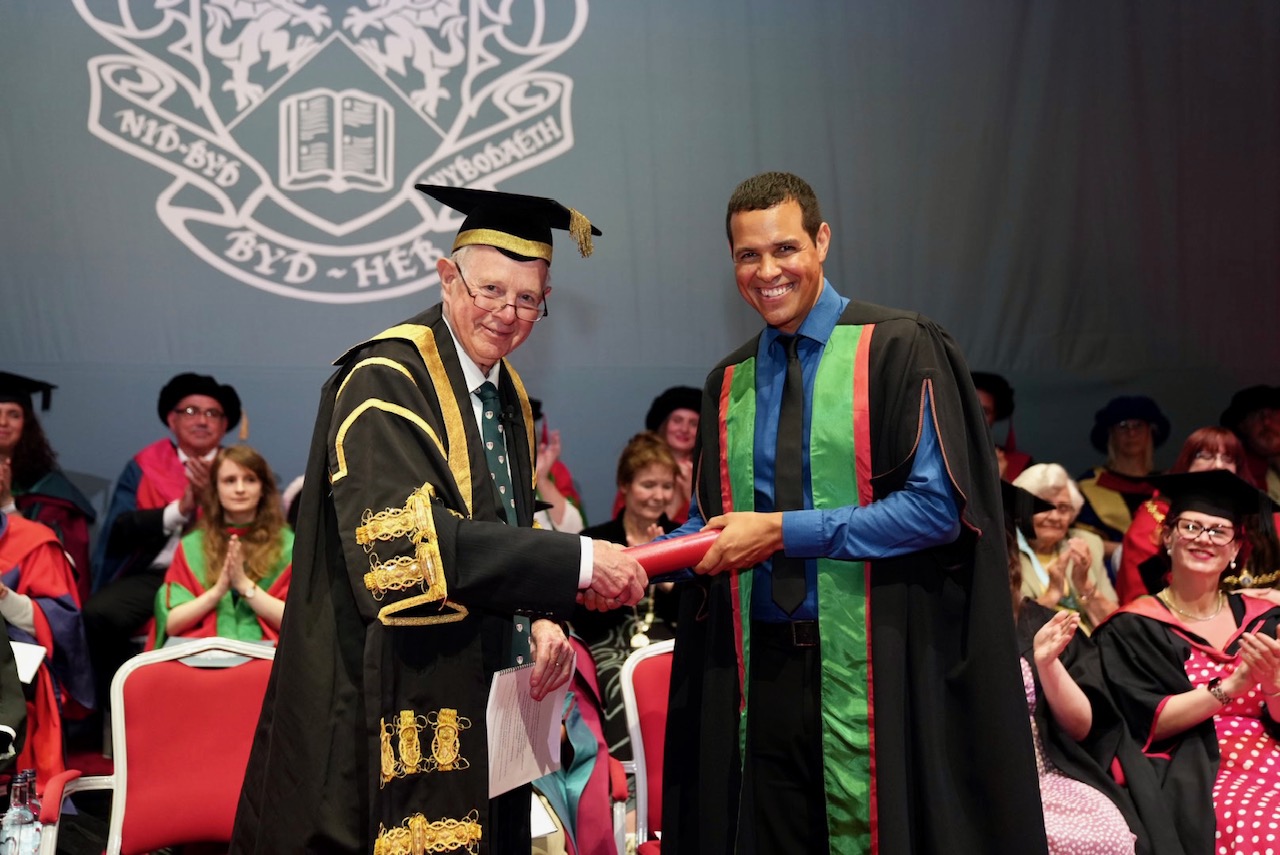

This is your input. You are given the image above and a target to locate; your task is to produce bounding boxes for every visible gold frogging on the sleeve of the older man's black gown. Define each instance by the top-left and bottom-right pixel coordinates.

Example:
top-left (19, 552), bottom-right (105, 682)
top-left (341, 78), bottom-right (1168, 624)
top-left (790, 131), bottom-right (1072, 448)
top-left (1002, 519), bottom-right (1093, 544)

top-left (356, 483), bottom-right (467, 626)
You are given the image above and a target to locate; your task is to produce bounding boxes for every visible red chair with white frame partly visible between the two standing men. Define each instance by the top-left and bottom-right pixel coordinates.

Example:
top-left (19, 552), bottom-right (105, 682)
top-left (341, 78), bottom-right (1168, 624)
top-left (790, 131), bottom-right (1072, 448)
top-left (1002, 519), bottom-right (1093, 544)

top-left (622, 641), bottom-right (676, 855)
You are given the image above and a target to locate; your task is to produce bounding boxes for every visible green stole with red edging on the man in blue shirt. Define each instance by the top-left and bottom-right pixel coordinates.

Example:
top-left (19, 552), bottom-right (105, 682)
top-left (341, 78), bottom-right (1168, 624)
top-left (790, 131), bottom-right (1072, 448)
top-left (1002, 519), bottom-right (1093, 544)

top-left (718, 325), bottom-right (874, 852)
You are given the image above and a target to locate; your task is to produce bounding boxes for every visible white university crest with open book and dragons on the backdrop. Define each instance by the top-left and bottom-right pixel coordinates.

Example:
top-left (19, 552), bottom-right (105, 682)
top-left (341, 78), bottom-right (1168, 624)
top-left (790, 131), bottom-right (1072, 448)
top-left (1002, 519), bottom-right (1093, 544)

top-left (72, 0), bottom-right (588, 303)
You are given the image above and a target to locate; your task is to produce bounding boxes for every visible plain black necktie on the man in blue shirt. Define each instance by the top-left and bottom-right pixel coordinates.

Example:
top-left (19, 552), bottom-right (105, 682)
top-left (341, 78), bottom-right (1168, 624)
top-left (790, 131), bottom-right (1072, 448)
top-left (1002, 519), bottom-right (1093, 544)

top-left (773, 335), bottom-right (805, 614)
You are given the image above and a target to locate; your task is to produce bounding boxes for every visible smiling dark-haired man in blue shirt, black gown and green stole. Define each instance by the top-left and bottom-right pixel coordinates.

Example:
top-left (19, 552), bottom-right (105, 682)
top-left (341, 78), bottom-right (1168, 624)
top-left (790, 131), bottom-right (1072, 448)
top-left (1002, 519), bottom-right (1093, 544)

top-left (662, 173), bottom-right (1046, 855)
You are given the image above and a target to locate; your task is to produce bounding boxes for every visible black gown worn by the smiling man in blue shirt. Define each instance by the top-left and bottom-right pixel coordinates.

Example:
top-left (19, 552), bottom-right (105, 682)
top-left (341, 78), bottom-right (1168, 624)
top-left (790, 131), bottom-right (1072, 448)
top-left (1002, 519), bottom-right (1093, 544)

top-left (662, 301), bottom-right (1046, 855)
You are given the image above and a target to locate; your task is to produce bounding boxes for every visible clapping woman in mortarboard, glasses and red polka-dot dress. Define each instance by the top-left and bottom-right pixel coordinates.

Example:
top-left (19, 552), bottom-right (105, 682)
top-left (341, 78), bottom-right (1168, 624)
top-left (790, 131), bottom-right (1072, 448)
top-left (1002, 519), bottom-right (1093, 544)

top-left (1094, 471), bottom-right (1280, 855)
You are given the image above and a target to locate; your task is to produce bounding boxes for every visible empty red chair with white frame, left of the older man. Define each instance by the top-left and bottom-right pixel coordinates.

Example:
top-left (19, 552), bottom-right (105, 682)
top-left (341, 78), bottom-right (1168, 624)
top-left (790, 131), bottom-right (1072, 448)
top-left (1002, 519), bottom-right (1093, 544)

top-left (41, 639), bottom-right (275, 855)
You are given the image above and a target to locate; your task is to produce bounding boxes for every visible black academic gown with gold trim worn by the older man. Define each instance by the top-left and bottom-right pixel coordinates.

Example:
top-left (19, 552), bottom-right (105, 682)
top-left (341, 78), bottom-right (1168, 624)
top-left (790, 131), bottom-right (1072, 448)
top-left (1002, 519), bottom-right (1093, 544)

top-left (232, 306), bottom-right (580, 855)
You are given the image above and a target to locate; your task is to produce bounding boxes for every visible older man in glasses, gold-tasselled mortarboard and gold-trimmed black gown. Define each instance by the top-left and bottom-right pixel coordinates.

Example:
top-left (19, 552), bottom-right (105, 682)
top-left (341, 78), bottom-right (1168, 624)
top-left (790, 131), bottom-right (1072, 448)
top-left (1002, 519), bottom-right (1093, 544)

top-left (232, 186), bottom-right (646, 855)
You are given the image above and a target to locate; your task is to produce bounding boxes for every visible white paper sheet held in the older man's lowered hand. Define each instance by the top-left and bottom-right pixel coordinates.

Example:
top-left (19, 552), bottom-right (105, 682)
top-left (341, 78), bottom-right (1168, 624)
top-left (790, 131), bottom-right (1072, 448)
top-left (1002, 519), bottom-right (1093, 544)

top-left (486, 664), bottom-right (568, 799)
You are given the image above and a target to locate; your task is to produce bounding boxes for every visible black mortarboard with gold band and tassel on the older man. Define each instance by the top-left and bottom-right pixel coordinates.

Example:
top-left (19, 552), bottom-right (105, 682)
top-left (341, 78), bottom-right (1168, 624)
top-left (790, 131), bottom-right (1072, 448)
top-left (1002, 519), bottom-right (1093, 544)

top-left (415, 184), bottom-right (603, 264)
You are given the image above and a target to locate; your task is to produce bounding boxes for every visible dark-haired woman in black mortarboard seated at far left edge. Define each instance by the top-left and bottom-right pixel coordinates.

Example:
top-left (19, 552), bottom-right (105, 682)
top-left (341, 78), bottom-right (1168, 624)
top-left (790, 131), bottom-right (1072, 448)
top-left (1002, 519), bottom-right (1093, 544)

top-left (0, 371), bottom-right (97, 602)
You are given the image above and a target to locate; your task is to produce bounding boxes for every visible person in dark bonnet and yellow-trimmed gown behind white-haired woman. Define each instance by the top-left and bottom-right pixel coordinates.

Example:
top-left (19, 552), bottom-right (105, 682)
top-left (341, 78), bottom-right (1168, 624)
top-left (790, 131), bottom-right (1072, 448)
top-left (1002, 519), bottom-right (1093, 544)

top-left (1079, 396), bottom-right (1169, 561)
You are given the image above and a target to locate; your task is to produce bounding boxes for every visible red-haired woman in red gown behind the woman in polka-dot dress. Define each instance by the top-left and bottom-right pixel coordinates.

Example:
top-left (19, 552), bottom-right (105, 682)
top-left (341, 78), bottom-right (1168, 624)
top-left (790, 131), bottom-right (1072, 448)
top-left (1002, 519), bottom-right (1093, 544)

top-left (1116, 426), bottom-right (1277, 605)
